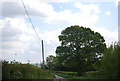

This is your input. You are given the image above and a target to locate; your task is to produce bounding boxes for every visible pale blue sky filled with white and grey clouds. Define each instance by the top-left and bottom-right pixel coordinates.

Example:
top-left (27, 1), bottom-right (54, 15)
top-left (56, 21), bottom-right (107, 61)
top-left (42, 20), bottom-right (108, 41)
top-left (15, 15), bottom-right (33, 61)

top-left (0, 0), bottom-right (119, 63)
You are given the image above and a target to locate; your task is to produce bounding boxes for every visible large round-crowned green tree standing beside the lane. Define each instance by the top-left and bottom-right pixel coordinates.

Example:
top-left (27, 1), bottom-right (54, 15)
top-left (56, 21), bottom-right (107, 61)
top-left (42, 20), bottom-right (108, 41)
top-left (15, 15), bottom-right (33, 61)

top-left (56, 25), bottom-right (106, 75)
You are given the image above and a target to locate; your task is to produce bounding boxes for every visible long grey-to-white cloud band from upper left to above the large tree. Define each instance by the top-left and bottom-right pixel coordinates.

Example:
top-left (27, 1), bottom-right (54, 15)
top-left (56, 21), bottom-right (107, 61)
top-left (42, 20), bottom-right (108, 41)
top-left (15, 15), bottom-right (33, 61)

top-left (2, 0), bottom-right (100, 26)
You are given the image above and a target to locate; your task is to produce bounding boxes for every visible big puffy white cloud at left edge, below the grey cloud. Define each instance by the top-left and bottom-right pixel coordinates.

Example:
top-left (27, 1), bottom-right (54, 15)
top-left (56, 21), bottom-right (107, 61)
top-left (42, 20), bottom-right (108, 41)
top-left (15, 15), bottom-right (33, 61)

top-left (0, 18), bottom-right (36, 61)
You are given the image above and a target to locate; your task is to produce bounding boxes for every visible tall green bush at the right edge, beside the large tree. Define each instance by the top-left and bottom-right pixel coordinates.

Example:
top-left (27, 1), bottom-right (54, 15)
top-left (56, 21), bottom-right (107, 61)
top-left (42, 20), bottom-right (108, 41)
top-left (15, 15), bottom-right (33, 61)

top-left (100, 45), bottom-right (120, 79)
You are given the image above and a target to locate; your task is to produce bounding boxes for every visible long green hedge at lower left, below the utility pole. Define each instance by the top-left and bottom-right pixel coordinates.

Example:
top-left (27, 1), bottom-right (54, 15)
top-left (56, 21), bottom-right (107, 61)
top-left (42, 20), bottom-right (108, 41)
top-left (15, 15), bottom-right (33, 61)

top-left (2, 62), bottom-right (53, 79)
